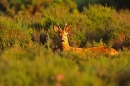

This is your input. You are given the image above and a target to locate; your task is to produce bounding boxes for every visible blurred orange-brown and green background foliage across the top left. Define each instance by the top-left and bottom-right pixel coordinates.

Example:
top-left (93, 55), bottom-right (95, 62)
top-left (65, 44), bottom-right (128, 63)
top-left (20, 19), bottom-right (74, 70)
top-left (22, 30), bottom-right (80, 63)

top-left (0, 0), bottom-right (77, 15)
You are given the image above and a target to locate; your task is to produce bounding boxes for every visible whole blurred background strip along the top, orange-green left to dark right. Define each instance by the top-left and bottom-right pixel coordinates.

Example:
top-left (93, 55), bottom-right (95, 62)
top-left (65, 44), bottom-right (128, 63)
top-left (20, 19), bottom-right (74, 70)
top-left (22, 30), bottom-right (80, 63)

top-left (0, 0), bottom-right (130, 15)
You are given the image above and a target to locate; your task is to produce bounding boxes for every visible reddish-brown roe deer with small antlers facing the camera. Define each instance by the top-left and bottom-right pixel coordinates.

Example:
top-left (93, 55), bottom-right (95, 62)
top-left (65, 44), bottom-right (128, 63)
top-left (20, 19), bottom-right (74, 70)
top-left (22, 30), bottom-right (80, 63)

top-left (54, 25), bottom-right (118, 55)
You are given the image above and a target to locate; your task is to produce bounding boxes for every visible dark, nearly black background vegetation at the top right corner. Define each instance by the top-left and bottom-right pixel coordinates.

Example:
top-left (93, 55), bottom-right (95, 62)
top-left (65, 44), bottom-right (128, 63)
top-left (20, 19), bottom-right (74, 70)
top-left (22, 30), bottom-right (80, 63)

top-left (75, 0), bottom-right (130, 10)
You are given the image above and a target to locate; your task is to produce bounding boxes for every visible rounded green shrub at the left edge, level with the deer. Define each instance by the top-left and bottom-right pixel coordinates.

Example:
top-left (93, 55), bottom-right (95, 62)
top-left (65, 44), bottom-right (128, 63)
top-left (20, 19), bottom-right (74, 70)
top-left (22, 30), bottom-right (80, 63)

top-left (0, 16), bottom-right (31, 49)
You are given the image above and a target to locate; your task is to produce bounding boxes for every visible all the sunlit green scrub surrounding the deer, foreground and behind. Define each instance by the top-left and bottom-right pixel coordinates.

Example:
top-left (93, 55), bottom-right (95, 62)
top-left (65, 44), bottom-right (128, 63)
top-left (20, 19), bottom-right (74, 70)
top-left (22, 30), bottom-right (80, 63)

top-left (0, 0), bottom-right (130, 86)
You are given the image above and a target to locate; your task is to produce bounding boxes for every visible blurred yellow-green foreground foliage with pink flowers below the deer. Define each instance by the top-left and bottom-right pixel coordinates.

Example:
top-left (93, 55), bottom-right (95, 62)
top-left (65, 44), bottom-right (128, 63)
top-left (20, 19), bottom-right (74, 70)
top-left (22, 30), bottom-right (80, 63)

top-left (0, 46), bottom-right (130, 86)
